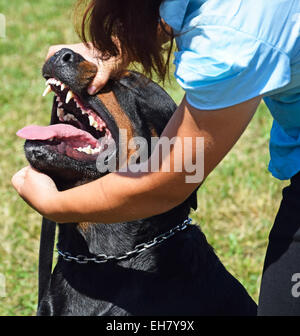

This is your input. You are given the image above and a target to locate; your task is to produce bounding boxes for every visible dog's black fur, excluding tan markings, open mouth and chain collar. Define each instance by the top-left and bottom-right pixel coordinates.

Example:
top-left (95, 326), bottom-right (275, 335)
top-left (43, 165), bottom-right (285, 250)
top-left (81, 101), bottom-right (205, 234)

top-left (25, 49), bottom-right (256, 316)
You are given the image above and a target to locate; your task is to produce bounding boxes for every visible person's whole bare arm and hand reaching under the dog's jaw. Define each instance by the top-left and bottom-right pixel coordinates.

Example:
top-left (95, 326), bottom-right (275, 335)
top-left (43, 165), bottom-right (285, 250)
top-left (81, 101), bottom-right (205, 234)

top-left (12, 97), bottom-right (261, 223)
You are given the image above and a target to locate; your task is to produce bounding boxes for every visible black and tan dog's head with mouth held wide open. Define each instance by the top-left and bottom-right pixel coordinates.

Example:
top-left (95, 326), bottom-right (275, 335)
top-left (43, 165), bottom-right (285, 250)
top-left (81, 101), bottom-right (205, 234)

top-left (18, 49), bottom-right (198, 210)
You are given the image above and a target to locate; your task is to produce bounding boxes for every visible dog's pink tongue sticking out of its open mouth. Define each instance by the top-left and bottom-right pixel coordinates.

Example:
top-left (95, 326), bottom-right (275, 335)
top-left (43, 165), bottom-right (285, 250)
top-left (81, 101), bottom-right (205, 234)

top-left (17, 124), bottom-right (98, 145)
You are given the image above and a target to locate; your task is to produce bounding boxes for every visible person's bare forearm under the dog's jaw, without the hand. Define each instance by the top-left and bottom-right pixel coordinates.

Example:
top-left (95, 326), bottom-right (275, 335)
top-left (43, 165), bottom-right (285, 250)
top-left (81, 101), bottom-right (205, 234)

top-left (55, 169), bottom-right (185, 223)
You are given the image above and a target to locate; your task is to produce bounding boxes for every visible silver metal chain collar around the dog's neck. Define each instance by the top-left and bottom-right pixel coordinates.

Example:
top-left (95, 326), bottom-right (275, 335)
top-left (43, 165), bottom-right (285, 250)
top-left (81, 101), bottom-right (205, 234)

top-left (57, 218), bottom-right (192, 264)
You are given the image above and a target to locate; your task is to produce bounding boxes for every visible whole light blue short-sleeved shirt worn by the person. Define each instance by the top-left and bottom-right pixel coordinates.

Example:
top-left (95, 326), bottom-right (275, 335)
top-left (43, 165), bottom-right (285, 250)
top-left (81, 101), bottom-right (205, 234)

top-left (160, 0), bottom-right (300, 180)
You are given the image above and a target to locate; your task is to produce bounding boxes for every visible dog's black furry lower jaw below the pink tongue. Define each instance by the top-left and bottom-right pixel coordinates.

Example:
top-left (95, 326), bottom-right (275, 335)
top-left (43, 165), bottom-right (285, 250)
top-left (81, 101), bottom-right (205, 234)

top-left (24, 140), bottom-right (107, 190)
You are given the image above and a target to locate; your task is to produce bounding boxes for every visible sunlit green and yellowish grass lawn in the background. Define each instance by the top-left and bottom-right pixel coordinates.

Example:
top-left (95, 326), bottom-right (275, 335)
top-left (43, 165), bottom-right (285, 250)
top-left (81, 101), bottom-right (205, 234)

top-left (0, 0), bottom-right (284, 315)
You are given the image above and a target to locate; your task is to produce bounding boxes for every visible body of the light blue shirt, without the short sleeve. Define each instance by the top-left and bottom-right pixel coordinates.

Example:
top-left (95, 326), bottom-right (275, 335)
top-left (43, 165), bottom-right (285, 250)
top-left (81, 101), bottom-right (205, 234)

top-left (161, 0), bottom-right (300, 179)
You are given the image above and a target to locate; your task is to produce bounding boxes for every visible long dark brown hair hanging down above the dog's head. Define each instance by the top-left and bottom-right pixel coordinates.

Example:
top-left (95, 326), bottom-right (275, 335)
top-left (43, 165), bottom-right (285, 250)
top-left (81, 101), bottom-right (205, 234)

top-left (76, 0), bottom-right (173, 80)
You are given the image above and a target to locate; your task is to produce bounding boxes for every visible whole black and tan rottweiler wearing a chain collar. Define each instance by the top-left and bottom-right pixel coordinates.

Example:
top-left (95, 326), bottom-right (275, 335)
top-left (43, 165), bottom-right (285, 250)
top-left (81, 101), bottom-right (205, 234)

top-left (19, 49), bottom-right (257, 316)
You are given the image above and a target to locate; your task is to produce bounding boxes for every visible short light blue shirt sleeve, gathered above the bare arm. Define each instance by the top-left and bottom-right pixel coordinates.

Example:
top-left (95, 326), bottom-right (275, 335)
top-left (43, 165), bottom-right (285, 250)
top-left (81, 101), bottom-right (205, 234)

top-left (174, 25), bottom-right (291, 110)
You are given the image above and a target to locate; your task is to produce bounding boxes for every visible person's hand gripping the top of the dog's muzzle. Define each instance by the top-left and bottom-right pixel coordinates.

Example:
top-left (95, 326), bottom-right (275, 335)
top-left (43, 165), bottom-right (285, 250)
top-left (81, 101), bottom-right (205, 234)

top-left (46, 43), bottom-right (127, 95)
